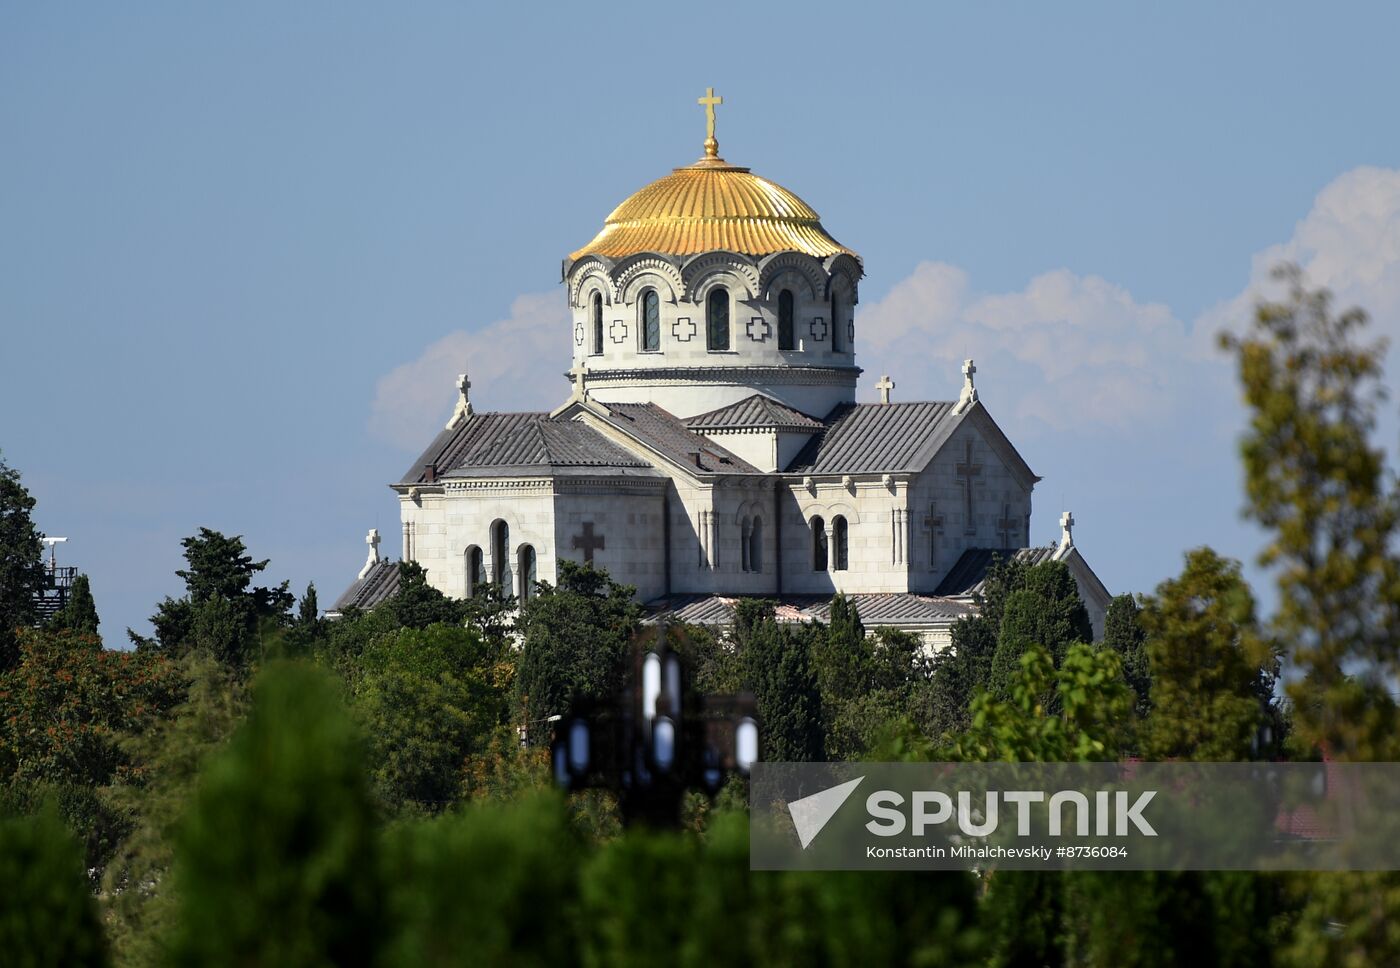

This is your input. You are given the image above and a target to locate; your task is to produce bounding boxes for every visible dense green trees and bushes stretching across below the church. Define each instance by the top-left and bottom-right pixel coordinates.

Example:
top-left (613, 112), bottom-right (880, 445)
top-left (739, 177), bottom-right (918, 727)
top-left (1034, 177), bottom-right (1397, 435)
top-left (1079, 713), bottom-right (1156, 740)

top-left (0, 273), bottom-right (1400, 967)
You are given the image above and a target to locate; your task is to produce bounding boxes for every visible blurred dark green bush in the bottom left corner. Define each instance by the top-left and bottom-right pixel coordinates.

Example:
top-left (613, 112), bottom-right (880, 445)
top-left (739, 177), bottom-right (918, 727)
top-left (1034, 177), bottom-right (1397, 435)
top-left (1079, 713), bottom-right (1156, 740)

top-left (0, 813), bottom-right (106, 968)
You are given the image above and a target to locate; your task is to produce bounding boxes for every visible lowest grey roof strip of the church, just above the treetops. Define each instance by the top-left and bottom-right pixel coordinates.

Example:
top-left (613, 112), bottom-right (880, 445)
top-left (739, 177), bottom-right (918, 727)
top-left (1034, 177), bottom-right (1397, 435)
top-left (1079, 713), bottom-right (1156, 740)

top-left (647, 593), bottom-right (974, 628)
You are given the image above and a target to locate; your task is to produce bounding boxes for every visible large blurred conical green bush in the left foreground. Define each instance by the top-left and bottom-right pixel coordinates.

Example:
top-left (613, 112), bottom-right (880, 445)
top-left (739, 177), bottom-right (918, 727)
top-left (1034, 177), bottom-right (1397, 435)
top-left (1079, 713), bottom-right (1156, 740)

top-left (167, 663), bottom-right (384, 965)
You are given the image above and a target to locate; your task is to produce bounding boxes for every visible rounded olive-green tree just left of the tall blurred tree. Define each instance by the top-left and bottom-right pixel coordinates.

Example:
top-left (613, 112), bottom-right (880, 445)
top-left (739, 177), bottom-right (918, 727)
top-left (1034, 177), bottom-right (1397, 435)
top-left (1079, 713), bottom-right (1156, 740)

top-left (1141, 548), bottom-right (1278, 761)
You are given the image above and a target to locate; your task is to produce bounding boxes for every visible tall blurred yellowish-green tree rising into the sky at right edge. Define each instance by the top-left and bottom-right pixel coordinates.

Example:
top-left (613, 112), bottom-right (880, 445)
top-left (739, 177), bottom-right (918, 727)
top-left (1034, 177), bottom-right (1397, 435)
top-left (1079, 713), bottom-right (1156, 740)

top-left (1222, 266), bottom-right (1400, 759)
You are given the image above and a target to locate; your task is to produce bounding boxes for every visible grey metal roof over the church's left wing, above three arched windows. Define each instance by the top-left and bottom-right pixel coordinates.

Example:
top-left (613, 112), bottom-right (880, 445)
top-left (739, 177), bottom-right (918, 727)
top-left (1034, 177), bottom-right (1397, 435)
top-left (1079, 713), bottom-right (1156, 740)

top-left (400, 412), bottom-right (650, 483)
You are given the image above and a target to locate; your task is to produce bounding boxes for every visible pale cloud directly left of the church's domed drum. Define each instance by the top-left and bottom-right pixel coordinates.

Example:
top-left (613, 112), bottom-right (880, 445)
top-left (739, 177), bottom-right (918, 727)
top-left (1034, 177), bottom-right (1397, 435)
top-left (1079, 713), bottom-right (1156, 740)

top-left (370, 290), bottom-right (570, 450)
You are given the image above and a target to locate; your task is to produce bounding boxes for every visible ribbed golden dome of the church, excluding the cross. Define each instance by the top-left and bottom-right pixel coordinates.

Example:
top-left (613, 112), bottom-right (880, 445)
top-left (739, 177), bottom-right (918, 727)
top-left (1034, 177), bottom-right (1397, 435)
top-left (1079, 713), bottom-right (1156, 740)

top-left (568, 156), bottom-right (860, 262)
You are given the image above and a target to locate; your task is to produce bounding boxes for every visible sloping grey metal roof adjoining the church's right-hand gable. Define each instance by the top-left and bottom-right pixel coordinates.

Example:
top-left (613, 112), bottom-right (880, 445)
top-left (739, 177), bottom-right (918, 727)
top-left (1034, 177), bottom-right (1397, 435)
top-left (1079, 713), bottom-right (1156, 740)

top-left (787, 401), bottom-right (955, 473)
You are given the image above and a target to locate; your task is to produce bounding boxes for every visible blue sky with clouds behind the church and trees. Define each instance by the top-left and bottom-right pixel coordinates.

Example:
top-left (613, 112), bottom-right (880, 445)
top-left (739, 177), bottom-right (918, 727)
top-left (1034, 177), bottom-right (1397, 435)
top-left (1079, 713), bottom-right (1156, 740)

top-left (0, 3), bottom-right (1400, 644)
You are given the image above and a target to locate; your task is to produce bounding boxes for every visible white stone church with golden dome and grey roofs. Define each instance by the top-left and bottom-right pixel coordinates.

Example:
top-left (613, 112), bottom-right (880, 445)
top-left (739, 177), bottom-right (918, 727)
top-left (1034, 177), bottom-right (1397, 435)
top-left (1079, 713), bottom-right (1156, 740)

top-left (332, 90), bottom-right (1109, 647)
